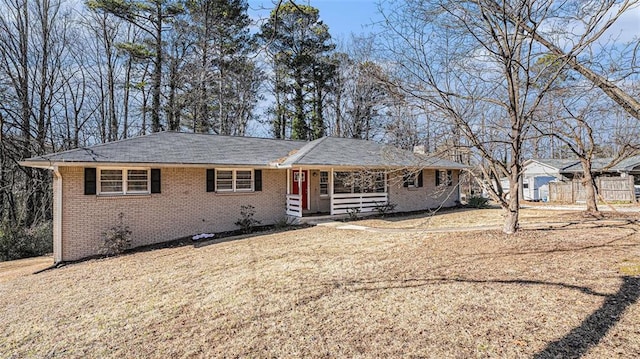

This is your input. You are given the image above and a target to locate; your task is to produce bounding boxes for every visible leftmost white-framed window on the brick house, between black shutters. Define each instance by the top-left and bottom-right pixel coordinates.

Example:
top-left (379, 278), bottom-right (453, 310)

top-left (98, 168), bottom-right (151, 195)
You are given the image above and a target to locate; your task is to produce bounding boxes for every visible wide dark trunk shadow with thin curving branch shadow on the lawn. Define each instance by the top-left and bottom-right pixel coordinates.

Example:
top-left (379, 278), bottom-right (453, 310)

top-left (345, 276), bottom-right (640, 359)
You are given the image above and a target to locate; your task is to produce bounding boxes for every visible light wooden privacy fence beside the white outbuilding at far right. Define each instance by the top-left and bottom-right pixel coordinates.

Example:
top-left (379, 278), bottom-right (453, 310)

top-left (549, 176), bottom-right (636, 203)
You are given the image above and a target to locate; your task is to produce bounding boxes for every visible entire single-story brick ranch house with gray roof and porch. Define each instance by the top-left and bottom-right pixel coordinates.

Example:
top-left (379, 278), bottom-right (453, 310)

top-left (21, 132), bottom-right (465, 263)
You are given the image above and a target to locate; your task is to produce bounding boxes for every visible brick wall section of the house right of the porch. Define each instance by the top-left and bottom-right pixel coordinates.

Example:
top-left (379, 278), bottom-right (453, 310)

top-left (387, 169), bottom-right (460, 212)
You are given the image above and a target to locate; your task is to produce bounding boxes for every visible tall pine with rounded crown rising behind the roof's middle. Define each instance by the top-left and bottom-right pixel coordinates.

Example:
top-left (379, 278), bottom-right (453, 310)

top-left (259, 2), bottom-right (335, 140)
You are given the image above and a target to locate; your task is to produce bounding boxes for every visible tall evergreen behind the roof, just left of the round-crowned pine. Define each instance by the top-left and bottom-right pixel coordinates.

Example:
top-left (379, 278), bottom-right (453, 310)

top-left (184, 0), bottom-right (261, 135)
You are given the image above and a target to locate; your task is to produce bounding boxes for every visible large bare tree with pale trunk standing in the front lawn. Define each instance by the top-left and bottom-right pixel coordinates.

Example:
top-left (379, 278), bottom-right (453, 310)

top-left (386, 0), bottom-right (636, 233)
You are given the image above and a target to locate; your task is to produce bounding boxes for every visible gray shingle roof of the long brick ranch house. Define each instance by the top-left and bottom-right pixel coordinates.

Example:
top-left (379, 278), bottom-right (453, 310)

top-left (23, 132), bottom-right (466, 169)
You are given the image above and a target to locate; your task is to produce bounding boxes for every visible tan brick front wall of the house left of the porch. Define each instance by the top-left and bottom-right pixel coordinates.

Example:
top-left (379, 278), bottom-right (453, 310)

top-left (60, 167), bottom-right (287, 261)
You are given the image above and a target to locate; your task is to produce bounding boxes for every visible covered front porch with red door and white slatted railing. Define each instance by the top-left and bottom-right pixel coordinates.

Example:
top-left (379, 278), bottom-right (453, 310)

top-left (286, 167), bottom-right (389, 218)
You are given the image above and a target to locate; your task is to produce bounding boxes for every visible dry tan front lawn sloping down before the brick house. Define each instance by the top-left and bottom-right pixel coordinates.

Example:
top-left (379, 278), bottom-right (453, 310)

top-left (0, 212), bottom-right (640, 358)
